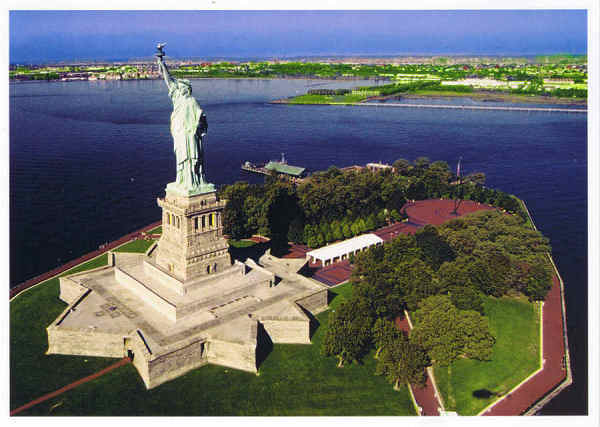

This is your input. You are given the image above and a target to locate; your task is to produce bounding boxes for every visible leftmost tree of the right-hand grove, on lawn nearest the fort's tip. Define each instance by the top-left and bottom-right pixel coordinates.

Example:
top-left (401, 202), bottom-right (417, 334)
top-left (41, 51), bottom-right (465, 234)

top-left (321, 298), bottom-right (373, 368)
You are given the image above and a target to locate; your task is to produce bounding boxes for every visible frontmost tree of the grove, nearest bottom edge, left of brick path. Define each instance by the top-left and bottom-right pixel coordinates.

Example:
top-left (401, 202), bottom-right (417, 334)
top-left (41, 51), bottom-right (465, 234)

top-left (375, 334), bottom-right (431, 390)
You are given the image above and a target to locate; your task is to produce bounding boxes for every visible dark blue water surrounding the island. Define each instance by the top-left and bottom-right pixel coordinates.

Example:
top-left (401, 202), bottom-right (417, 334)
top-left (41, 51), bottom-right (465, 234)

top-left (10, 79), bottom-right (587, 414)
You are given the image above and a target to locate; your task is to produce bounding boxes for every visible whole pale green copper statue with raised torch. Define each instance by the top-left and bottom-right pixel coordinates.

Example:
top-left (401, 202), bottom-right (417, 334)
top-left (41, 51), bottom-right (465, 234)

top-left (156, 43), bottom-right (215, 195)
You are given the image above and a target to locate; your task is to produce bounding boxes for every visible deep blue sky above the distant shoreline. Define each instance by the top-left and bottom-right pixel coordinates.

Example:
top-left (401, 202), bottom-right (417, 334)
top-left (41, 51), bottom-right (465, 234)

top-left (9, 10), bottom-right (587, 63)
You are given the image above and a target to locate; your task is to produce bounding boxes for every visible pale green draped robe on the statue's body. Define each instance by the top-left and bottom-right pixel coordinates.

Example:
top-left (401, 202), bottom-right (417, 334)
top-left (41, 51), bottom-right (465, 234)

top-left (169, 85), bottom-right (204, 189)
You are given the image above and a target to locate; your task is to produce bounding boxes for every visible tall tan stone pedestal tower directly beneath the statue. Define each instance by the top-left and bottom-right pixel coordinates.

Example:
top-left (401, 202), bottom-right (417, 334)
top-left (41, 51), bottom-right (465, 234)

top-left (156, 184), bottom-right (231, 282)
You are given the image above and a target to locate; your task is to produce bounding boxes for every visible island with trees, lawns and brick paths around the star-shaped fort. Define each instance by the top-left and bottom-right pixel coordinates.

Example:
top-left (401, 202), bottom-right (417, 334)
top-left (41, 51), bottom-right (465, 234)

top-left (10, 157), bottom-right (571, 415)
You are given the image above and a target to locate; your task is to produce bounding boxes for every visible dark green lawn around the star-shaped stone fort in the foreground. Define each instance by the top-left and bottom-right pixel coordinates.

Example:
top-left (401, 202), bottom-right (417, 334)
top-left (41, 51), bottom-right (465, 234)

top-left (10, 266), bottom-right (415, 416)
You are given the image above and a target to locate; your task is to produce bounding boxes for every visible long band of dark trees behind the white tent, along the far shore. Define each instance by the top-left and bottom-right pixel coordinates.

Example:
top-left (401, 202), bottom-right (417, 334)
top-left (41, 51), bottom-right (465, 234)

top-left (221, 157), bottom-right (526, 252)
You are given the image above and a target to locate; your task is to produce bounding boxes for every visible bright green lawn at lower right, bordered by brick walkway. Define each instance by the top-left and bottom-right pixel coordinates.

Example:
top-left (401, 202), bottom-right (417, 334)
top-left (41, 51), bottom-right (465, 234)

top-left (434, 297), bottom-right (540, 415)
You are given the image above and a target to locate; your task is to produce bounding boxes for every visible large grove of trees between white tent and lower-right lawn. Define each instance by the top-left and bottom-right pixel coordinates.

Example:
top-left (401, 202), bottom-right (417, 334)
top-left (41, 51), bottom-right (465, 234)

top-left (322, 211), bottom-right (552, 387)
